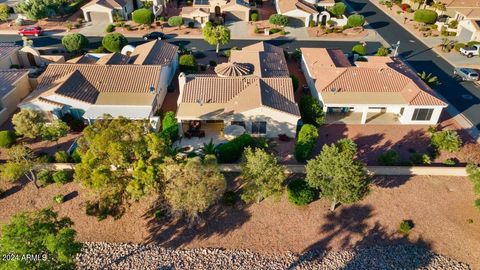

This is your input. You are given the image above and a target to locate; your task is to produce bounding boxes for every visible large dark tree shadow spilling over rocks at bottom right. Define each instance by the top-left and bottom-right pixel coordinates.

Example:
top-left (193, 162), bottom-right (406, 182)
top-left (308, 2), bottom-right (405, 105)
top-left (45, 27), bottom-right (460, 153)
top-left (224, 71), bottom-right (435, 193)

top-left (288, 205), bottom-right (433, 270)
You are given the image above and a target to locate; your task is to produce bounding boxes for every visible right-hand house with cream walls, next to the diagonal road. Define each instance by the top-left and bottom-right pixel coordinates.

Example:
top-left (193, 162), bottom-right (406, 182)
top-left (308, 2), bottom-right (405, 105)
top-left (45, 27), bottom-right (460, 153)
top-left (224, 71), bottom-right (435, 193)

top-left (301, 48), bottom-right (447, 125)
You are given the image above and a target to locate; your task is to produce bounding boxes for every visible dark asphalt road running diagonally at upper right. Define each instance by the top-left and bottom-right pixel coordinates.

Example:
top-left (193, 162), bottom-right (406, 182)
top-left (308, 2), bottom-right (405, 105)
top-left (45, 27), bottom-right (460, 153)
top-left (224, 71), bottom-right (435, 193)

top-left (345, 0), bottom-right (480, 129)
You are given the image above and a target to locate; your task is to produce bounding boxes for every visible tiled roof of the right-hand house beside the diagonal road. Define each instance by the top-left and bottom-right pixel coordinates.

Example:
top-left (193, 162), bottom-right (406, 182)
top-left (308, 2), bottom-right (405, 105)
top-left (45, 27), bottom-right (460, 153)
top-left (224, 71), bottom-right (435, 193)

top-left (301, 48), bottom-right (446, 106)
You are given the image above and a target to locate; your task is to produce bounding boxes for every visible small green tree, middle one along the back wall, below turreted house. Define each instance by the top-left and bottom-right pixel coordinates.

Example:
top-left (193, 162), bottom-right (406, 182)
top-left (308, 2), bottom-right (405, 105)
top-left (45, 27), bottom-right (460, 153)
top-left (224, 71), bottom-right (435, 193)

top-left (241, 147), bottom-right (286, 203)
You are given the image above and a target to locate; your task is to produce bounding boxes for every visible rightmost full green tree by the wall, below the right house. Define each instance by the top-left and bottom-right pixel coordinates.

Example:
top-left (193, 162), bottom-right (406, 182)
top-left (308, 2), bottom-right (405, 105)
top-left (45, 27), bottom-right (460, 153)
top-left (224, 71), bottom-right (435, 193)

top-left (306, 139), bottom-right (369, 211)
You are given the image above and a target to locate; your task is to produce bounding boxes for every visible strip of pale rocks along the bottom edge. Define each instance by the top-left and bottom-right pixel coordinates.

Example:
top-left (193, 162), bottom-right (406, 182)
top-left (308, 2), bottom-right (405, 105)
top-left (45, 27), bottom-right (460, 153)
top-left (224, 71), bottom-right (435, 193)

top-left (77, 243), bottom-right (471, 270)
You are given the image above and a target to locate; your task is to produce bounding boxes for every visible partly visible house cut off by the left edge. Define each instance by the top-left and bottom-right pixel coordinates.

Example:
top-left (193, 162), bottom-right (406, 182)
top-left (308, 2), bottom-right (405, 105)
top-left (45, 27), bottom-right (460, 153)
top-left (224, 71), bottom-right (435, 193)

top-left (0, 69), bottom-right (31, 125)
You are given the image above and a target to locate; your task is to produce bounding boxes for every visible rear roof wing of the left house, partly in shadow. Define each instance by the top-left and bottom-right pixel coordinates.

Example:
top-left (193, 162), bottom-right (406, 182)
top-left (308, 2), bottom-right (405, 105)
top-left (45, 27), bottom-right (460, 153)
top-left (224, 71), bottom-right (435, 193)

top-left (130, 40), bottom-right (178, 65)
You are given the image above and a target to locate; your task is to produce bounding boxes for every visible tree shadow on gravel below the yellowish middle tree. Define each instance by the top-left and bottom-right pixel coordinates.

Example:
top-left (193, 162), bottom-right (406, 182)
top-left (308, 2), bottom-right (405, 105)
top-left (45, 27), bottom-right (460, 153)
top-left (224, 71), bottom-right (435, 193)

top-left (144, 173), bottom-right (250, 248)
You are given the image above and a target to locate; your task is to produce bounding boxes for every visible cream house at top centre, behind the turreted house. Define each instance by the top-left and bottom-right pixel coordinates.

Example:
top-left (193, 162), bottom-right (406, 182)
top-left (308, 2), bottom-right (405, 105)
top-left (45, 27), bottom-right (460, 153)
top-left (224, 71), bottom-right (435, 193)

top-left (180, 0), bottom-right (250, 25)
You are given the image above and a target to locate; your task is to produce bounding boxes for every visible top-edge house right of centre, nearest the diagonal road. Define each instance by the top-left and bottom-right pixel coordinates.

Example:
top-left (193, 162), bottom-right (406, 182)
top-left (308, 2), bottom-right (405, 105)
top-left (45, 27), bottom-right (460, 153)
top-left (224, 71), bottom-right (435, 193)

top-left (275, 0), bottom-right (335, 27)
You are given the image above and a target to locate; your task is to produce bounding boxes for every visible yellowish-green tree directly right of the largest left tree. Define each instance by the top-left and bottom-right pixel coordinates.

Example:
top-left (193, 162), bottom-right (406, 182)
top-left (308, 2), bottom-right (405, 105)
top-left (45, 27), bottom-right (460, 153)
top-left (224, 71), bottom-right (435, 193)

top-left (163, 155), bottom-right (227, 221)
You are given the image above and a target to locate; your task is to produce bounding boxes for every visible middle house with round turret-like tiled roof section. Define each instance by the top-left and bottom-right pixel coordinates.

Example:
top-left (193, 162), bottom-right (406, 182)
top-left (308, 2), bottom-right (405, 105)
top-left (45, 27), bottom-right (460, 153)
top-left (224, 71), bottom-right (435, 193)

top-left (177, 42), bottom-right (300, 137)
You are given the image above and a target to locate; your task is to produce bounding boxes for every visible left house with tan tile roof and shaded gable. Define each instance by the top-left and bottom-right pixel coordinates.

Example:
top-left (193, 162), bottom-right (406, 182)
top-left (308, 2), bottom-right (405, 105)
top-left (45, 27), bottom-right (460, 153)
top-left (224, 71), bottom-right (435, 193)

top-left (19, 41), bottom-right (178, 126)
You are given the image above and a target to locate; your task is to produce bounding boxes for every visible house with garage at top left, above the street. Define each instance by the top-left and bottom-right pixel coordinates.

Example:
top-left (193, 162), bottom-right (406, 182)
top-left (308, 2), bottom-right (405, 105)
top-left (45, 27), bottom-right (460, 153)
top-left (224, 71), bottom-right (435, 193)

top-left (81, 0), bottom-right (165, 23)
